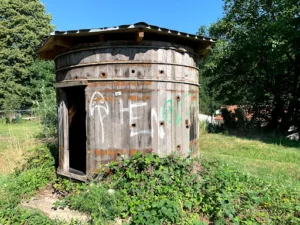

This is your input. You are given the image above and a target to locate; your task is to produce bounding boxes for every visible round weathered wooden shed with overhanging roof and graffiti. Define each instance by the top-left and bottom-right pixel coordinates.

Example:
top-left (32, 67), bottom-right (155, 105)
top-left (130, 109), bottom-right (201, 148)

top-left (38, 22), bottom-right (214, 180)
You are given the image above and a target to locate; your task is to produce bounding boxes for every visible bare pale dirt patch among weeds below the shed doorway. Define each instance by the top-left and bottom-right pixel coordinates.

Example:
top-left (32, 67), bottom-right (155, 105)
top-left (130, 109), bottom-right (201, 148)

top-left (21, 186), bottom-right (90, 224)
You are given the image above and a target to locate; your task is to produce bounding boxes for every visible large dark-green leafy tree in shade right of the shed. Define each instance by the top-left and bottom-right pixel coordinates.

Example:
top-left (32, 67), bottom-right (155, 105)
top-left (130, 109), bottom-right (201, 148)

top-left (202, 0), bottom-right (300, 131)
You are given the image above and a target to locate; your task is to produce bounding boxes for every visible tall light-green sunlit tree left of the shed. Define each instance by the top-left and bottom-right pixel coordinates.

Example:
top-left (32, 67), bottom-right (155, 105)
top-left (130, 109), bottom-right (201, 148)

top-left (0, 0), bottom-right (53, 109)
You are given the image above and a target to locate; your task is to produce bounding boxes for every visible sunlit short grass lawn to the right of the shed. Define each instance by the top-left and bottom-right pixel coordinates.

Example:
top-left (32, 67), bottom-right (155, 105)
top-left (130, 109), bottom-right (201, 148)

top-left (200, 128), bottom-right (300, 190)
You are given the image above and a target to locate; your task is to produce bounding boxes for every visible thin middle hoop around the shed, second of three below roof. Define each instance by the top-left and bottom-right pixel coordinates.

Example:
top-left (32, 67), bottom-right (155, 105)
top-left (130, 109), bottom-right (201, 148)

top-left (55, 61), bottom-right (199, 73)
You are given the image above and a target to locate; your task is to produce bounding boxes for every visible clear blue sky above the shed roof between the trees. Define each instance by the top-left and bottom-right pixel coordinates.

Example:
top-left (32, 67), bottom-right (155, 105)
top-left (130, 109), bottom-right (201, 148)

top-left (41, 0), bottom-right (223, 34)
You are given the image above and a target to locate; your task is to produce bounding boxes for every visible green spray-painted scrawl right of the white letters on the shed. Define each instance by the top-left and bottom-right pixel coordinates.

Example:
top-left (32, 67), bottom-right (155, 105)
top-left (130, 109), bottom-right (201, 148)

top-left (161, 93), bottom-right (191, 126)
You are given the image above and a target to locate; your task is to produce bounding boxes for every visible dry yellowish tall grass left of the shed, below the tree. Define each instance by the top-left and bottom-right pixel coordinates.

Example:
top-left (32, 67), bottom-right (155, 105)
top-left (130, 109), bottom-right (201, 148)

top-left (0, 121), bottom-right (41, 175)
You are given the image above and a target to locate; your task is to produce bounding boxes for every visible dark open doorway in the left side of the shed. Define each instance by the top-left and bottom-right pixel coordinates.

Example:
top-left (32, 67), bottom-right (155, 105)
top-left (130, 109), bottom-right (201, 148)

top-left (64, 86), bottom-right (87, 175)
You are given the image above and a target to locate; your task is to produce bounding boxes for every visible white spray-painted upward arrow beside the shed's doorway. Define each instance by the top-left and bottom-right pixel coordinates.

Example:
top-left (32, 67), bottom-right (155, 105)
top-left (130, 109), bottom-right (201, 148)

top-left (89, 91), bottom-right (109, 143)
